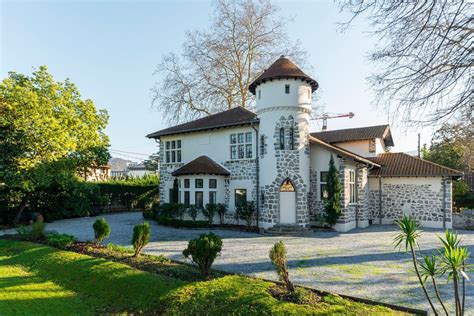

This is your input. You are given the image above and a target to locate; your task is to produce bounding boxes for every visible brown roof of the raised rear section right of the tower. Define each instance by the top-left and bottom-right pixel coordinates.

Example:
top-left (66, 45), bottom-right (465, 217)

top-left (311, 125), bottom-right (394, 146)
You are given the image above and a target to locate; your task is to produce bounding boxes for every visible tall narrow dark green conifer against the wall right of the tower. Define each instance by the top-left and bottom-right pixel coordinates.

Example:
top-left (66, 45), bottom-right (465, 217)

top-left (324, 155), bottom-right (342, 225)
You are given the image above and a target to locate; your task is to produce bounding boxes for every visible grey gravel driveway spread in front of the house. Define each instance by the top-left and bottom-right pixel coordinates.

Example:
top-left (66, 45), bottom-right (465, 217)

top-left (4, 213), bottom-right (474, 315)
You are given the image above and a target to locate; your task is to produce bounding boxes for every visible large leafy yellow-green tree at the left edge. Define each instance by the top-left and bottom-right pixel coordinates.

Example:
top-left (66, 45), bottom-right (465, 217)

top-left (0, 66), bottom-right (109, 224)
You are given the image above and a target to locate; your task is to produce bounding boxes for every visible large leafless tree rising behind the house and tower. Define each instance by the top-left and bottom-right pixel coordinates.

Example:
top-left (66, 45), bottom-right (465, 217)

top-left (152, 0), bottom-right (307, 123)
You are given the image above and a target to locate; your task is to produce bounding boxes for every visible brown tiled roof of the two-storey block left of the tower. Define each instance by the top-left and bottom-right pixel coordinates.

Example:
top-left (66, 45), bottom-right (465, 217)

top-left (146, 106), bottom-right (257, 138)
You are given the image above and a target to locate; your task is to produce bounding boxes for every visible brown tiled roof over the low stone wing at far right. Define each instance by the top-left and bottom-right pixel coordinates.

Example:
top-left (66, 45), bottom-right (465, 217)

top-left (367, 153), bottom-right (463, 177)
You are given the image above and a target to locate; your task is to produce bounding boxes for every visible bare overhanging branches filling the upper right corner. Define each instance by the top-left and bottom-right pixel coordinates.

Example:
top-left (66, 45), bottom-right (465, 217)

top-left (340, 0), bottom-right (474, 125)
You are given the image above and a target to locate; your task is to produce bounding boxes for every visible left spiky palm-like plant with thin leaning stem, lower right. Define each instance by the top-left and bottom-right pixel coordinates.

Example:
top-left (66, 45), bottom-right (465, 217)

top-left (394, 216), bottom-right (438, 315)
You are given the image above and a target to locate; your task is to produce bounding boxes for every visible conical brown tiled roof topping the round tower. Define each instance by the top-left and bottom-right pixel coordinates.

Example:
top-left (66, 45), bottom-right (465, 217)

top-left (249, 55), bottom-right (319, 95)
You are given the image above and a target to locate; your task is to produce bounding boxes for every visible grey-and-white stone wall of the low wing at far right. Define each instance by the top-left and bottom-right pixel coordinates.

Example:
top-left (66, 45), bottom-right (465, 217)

top-left (369, 177), bottom-right (452, 225)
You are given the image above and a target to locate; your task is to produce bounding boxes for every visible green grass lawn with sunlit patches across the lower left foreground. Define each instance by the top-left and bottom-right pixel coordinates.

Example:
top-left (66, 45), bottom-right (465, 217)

top-left (0, 240), bottom-right (408, 315)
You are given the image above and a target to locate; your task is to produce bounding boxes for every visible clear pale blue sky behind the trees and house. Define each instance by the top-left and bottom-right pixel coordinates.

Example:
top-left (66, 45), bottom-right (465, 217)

top-left (0, 0), bottom-right (432, 161)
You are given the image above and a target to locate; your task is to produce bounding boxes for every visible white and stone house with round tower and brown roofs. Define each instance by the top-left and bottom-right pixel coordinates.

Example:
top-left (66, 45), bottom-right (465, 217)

top-left (147, 56), bottom-right (461, 232)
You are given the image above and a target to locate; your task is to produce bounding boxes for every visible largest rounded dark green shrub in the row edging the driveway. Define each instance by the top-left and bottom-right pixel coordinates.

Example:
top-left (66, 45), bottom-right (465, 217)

top-left (183, 233), bottom-right (222, 276)
